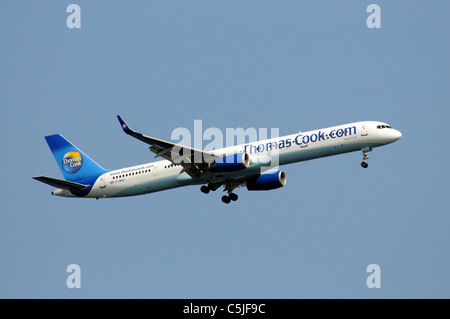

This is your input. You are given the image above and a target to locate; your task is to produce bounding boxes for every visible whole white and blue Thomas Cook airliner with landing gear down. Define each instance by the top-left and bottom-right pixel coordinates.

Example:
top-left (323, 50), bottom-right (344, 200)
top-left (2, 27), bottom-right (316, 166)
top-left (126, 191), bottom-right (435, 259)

top-left (33, 115), bottom-right (402, 204)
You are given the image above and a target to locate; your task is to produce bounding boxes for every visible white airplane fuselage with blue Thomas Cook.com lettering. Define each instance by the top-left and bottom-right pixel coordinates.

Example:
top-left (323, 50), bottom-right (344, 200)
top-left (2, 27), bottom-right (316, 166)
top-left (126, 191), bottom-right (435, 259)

top-left (53, 121), bottom-right (402, 198)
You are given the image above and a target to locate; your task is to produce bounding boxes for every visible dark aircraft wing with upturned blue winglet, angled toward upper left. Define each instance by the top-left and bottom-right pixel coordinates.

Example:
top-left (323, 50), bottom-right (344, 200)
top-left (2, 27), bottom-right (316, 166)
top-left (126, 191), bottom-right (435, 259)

top-left (117, 115), bottom-right (219, 178)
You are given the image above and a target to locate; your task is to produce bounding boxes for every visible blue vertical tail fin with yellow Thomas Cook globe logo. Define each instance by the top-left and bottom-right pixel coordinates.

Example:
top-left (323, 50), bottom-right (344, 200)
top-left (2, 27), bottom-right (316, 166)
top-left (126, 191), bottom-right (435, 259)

top-left (45, 134), bottom-right (107, 182)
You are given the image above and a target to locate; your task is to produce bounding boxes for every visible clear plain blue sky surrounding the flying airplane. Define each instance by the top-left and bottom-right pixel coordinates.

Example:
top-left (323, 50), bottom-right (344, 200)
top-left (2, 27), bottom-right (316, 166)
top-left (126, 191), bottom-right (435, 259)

top-left (0, 0), bottom-right (450, 298)
